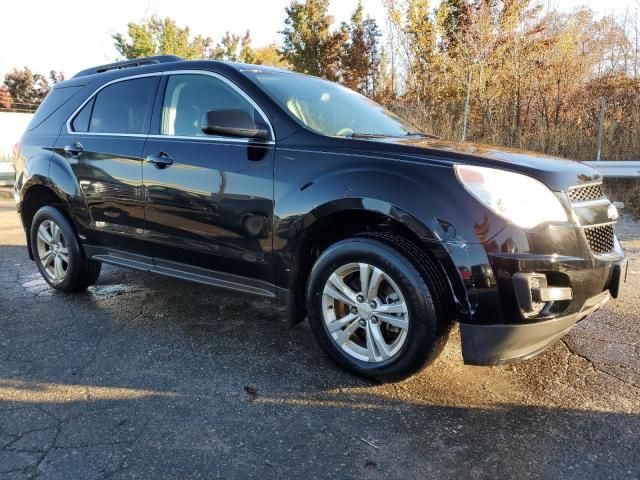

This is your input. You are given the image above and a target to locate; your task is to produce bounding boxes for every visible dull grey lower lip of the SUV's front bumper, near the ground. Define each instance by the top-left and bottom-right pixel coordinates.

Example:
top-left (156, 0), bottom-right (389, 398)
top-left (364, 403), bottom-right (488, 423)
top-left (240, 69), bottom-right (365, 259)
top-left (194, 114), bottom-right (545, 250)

top-left (460, 260), bottom-right (627, 365)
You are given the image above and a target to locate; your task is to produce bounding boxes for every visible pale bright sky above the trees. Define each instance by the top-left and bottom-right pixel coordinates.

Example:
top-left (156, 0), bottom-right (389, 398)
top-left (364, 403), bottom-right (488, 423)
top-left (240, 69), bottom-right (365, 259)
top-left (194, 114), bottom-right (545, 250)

top-left (0, 0), bottom-right (640, 78)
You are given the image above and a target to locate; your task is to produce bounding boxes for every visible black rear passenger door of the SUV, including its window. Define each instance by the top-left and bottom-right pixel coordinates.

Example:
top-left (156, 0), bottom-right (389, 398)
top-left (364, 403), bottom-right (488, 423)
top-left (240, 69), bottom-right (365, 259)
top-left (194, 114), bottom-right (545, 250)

top-left (55, 75), bottom-right (161, 253)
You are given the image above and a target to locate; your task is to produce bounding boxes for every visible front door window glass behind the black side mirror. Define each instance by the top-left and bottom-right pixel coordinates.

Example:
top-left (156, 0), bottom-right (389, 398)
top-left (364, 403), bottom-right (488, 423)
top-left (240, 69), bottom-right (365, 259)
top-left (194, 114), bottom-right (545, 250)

top-left (160, 74), bottom-right (267, 137)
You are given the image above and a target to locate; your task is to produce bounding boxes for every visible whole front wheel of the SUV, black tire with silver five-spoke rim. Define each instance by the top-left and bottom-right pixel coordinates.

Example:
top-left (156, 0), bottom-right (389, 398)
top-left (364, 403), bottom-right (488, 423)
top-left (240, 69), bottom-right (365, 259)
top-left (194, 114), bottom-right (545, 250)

top-left (306, 234), bottom-right (452, 382)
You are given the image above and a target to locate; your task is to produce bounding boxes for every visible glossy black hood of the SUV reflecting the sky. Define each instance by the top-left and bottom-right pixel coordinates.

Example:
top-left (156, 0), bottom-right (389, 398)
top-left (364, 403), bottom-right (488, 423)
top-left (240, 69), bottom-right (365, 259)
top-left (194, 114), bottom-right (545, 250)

top-left (344, 137), bottom-right (602, 191)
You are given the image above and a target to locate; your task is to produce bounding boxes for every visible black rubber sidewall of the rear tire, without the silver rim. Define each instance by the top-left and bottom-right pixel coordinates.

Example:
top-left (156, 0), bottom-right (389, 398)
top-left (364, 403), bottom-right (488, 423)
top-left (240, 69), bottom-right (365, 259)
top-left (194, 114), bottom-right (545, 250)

top-left (30, 206), bottom-right (86, 291)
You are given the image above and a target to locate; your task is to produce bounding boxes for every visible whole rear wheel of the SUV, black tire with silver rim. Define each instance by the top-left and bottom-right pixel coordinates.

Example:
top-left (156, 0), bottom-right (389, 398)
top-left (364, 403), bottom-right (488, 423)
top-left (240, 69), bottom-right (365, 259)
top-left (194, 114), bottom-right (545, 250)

top-left (30, 206), bottom-right (101, 293)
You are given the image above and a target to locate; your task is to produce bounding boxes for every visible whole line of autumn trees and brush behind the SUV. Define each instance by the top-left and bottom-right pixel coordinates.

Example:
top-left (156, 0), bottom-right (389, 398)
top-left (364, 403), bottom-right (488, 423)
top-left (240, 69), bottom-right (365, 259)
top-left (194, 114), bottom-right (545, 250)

top-left (0, 0), bottom-right (640, 160)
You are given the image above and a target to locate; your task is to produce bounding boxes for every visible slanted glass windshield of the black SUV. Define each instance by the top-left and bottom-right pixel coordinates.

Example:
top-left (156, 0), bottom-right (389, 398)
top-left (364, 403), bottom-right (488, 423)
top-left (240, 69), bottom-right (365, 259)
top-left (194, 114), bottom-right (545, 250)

top-left (245, 72), bottom-right (420, 137)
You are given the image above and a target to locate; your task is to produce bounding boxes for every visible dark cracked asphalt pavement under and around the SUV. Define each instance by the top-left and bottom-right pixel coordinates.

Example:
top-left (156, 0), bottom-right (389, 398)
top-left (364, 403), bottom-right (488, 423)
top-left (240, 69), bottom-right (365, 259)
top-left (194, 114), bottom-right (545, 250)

top-left (0, 198), bottom-right (640, 480)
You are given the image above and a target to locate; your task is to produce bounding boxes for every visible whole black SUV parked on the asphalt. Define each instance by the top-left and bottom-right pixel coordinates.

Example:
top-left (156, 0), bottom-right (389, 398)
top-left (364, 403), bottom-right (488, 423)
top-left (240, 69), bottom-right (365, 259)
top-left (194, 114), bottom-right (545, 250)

top-left (15, 56), bottom-right (626, 381)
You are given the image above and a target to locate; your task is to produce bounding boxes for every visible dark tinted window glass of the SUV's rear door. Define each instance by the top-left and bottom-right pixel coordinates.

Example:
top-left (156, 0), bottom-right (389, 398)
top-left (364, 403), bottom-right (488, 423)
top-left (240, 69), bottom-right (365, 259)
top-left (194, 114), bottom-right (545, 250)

top-left (71, 77), bottom-right (158, 134)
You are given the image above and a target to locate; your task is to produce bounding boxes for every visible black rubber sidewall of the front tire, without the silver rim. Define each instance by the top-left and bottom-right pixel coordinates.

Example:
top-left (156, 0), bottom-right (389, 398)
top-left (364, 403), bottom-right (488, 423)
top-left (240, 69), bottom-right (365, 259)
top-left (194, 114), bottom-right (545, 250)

top-left (307, 238), bottom-right (438, 381)
